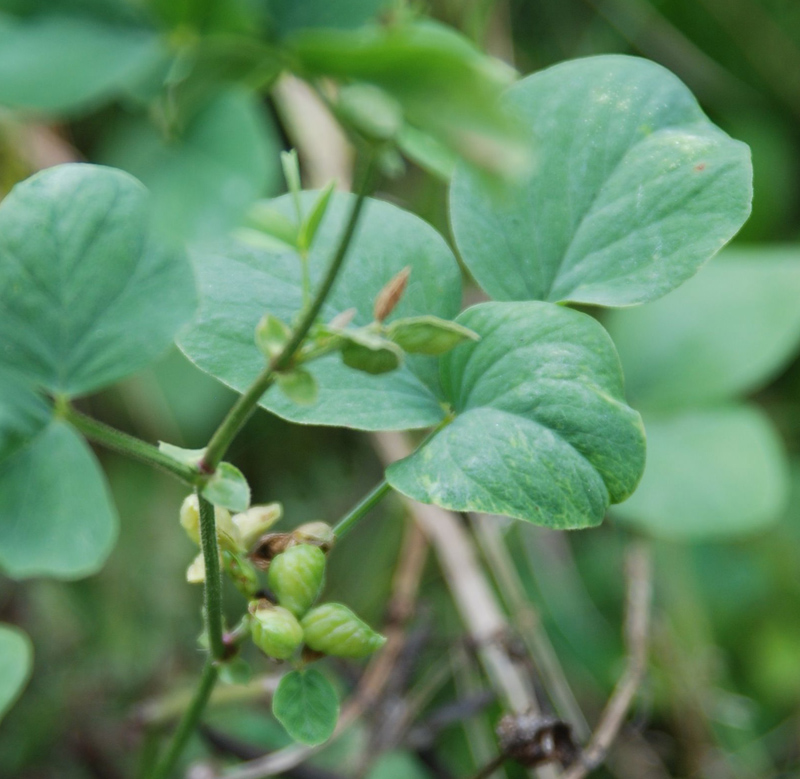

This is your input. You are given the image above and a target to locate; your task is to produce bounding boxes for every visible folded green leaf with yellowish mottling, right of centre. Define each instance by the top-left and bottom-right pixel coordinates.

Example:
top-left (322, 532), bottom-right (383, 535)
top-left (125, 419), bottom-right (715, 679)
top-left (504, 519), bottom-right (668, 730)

top-left (386, 303), bottom-right (645, 528)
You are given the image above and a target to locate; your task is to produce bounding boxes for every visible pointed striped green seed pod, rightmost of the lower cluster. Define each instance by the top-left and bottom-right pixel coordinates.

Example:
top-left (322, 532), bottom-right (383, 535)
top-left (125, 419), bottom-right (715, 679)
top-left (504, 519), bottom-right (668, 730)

top-left (300, 603), bottom-right (386, 658)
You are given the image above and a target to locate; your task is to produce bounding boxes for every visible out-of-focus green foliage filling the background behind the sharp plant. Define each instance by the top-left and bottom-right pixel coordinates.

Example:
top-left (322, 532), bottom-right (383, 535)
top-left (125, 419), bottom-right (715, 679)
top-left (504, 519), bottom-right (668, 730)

top-left (0, 0), bottom-right (800, 779)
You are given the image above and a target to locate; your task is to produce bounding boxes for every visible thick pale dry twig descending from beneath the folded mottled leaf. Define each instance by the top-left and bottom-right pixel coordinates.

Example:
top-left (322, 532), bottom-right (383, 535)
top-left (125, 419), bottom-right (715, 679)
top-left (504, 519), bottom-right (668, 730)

top-left (374, 433), bottom-right (560, 779)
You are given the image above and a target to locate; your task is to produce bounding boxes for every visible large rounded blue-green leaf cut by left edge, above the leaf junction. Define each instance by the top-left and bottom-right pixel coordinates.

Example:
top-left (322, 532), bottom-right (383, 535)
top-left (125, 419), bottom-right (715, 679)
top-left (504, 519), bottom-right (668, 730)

top-left (0, 165), bottom-right (196, 396)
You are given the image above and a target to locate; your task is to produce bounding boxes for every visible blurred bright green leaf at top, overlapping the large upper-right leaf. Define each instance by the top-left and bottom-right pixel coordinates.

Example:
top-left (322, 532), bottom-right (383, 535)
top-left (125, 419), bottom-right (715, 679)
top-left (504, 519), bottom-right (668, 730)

top-left (287, 21), bottom-right (528, 174)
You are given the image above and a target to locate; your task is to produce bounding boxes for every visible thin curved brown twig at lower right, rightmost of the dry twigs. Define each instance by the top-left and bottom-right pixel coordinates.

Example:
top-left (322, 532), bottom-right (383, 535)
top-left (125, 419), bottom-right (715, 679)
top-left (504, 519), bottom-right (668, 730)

top-left (564, 541), bottom-right (652, 779)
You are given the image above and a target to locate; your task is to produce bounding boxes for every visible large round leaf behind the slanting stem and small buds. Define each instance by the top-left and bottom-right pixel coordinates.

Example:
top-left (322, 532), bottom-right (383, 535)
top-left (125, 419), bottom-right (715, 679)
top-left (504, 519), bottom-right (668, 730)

top-left (180, 192), bottom-right (461, 430)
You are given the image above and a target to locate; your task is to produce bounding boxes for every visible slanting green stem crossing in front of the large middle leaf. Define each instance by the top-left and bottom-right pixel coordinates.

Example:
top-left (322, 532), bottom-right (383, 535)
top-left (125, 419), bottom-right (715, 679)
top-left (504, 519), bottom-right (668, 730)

top-left (200, 152), bottom-right (374, 473)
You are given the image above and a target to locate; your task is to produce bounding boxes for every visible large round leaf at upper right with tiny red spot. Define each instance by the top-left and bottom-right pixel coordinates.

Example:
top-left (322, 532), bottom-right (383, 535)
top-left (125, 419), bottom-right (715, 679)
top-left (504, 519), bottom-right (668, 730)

top-left (451, 56), bottom-right (752, 306)
